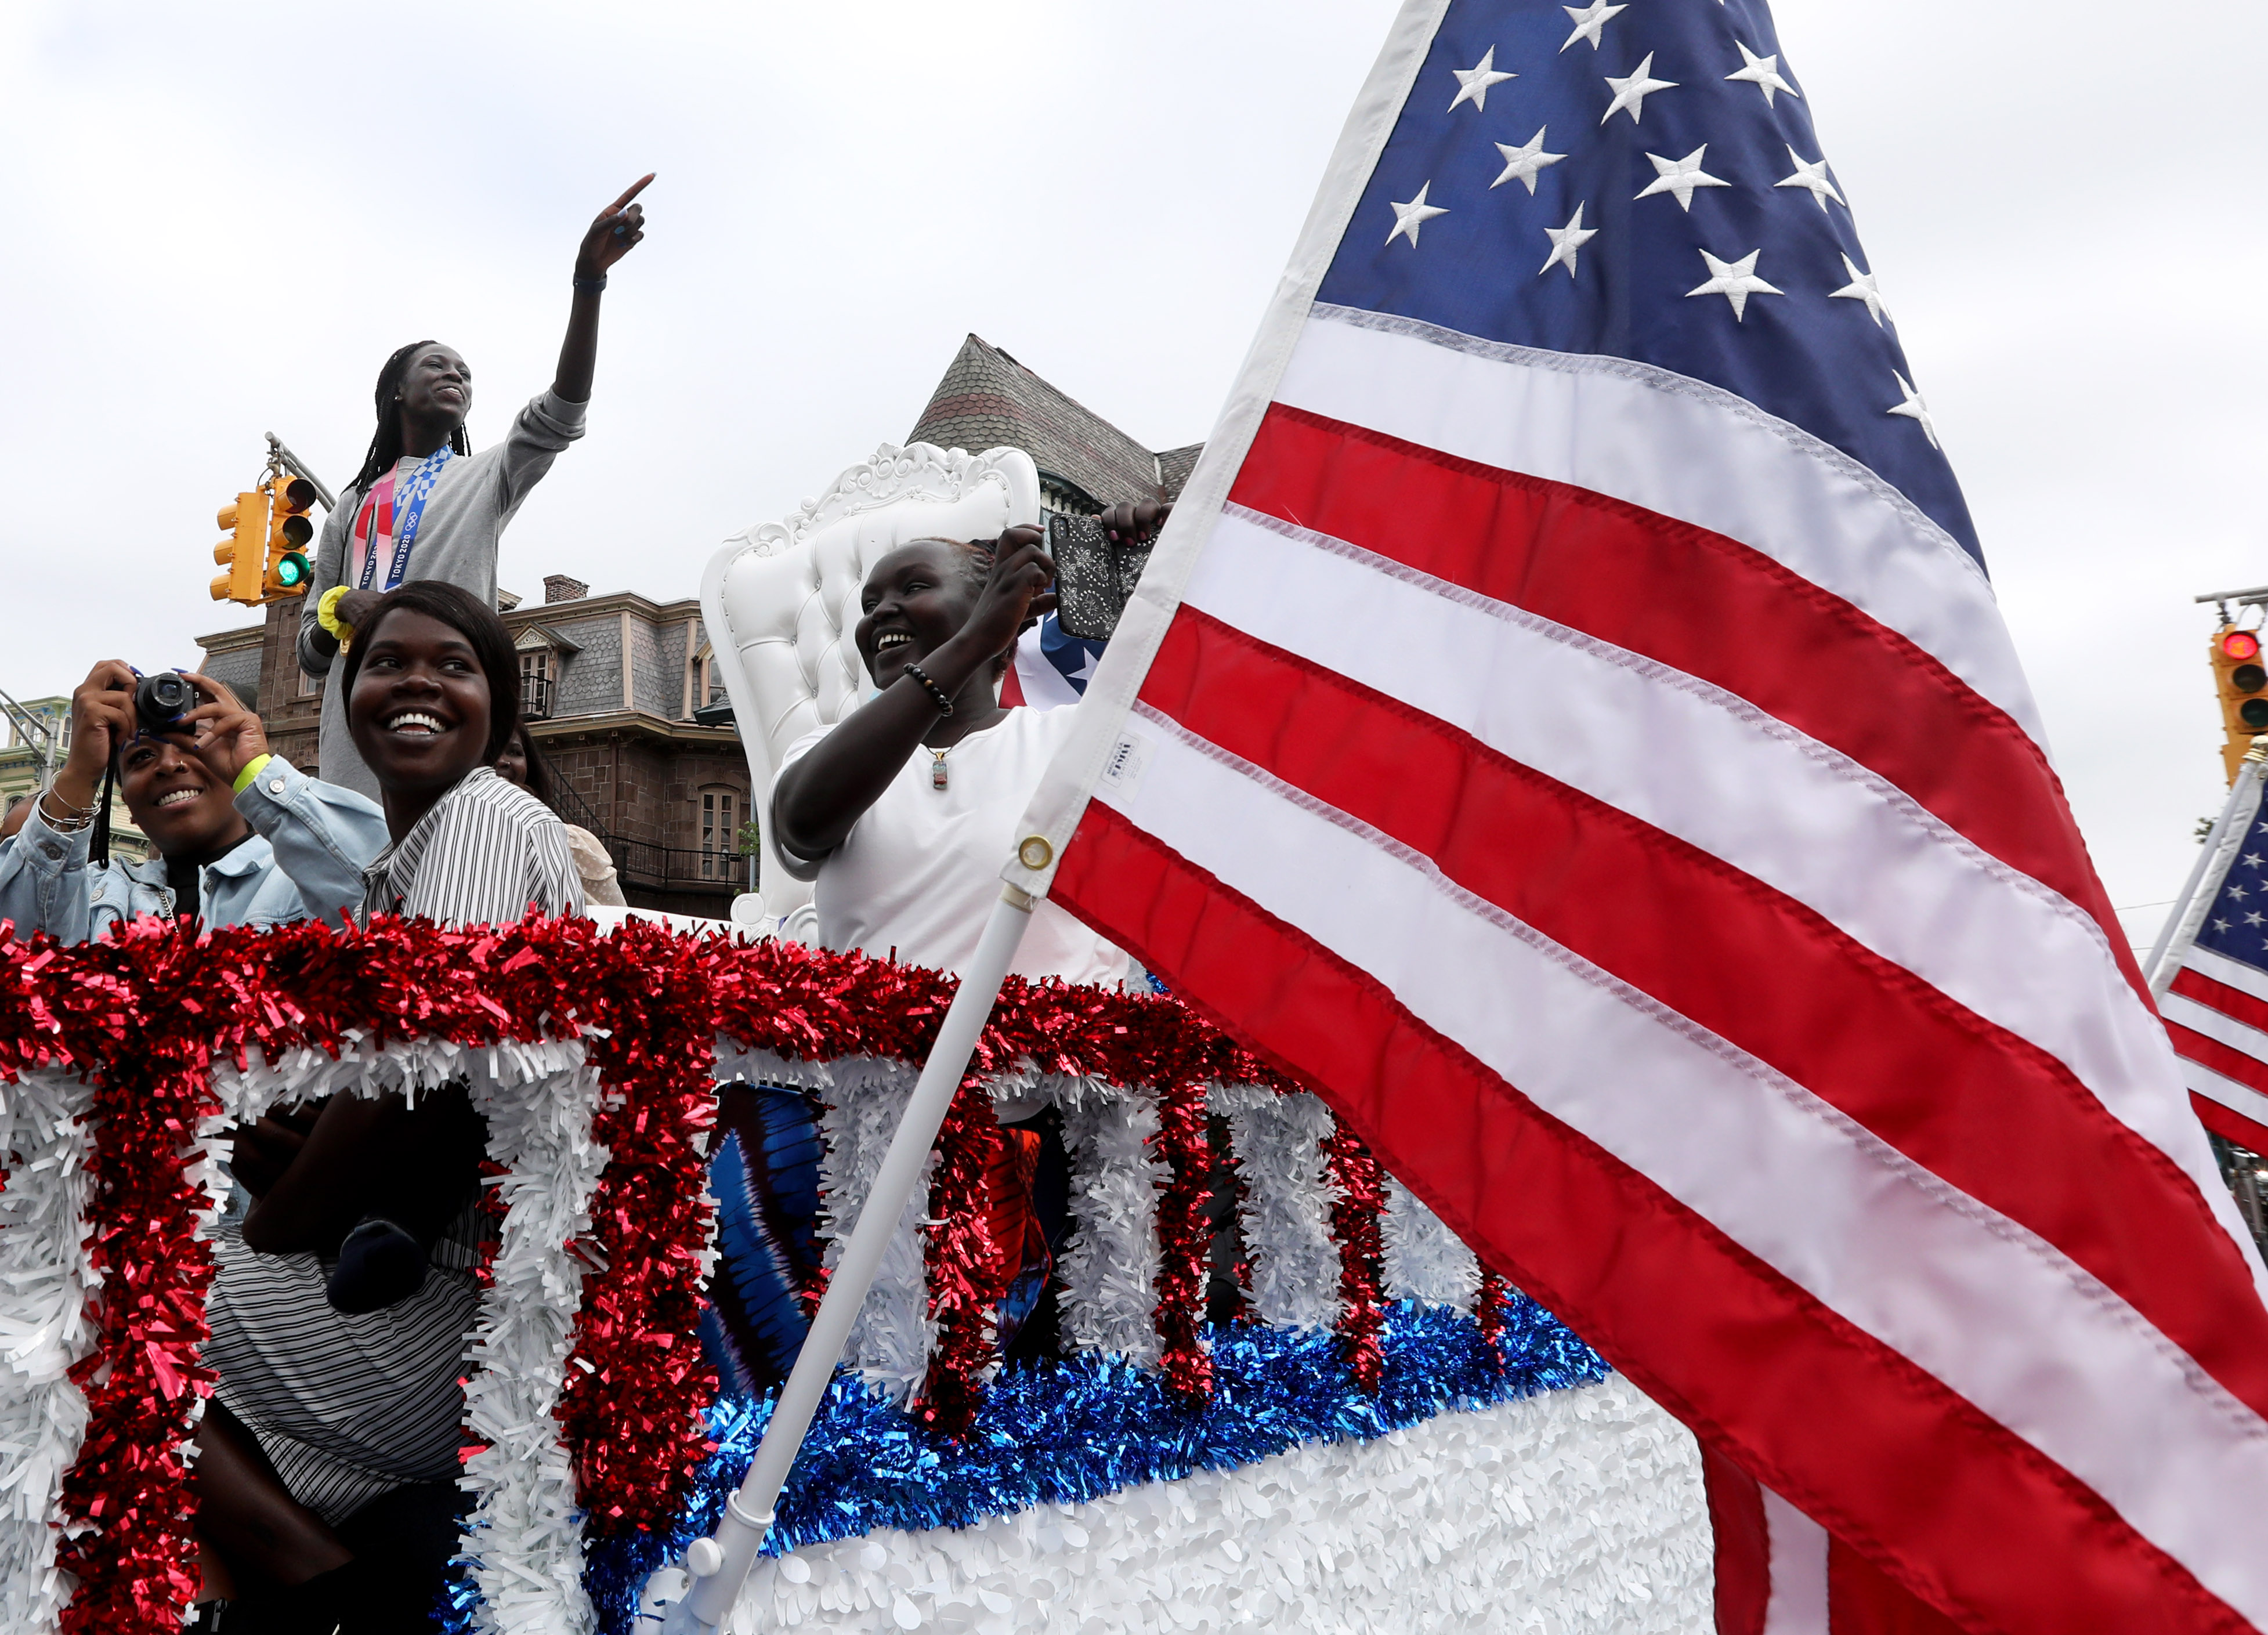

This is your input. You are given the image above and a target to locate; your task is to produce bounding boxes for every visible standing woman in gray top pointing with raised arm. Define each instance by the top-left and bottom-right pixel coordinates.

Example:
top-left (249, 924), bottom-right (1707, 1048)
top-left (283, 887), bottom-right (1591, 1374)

top-left (299, 175), bottom-right (653, 798)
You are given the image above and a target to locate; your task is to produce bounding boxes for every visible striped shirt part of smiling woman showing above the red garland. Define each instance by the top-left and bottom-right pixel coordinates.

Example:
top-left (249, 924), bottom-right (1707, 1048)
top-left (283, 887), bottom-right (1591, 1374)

top-left (363, 766), bottom-right (583, 925)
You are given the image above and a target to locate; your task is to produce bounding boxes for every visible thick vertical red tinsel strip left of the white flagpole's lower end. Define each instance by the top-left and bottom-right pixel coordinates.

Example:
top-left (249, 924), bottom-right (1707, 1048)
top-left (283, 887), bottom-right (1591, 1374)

top-left (558, 921), bottom-right (717, 1538)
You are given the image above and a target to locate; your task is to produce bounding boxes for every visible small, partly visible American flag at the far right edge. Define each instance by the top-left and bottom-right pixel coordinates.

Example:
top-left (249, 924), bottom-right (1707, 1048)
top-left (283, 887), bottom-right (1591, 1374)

top-left (2153, 762), bottom-right (2268, 1152)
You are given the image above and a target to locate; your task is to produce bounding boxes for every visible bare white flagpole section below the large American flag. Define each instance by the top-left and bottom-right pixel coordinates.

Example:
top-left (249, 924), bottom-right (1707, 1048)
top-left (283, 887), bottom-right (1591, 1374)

top-left (664, 887), bottom-right (1039, 1635)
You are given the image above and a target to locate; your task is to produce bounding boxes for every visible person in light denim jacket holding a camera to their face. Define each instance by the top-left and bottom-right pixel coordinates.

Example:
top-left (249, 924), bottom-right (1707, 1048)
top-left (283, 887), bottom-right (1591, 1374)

top-left (0, 657), bottom-right (386, 943)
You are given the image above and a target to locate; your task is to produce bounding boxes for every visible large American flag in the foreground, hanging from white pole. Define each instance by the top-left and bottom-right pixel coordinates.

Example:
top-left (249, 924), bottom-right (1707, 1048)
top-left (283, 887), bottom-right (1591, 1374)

top-left (1007, 0), bottom-right (2268, 1633)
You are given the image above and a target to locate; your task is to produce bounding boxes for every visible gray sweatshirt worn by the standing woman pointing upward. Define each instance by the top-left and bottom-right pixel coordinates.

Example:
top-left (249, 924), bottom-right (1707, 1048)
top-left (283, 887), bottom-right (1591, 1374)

top-left (299, 392), bottom-right (587, 801)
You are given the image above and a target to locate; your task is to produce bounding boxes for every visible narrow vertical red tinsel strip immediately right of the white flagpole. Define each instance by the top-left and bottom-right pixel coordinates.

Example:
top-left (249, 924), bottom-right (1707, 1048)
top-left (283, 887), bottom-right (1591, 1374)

top-left (921, 1077), bottom-right (1005, 1435)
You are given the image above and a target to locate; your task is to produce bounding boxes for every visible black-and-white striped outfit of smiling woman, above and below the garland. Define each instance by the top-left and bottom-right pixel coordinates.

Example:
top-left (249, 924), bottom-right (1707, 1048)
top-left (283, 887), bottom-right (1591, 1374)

top-left (207, 766), bottom-right (583, 1522)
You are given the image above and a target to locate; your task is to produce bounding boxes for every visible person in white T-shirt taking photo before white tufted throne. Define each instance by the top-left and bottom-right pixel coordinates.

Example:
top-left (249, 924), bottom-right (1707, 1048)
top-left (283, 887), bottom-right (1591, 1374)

top-left (764, 529), bottom-right (1127, 984)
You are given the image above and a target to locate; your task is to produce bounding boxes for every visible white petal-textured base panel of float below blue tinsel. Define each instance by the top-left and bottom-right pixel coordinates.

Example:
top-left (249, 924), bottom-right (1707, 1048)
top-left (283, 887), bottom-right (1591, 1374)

top-left (719, 1379), bottom-right (1712, 1635)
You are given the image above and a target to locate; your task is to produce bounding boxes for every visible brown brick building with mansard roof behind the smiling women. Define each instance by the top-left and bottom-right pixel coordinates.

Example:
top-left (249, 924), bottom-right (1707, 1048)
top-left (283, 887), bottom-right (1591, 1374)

top-left (197, 574), bottom-right (751, 918)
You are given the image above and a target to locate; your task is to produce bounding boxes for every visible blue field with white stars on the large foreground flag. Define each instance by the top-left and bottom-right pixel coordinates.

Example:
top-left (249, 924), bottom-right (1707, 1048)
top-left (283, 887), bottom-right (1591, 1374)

top-left (1315, 0), bottom-right (1982, 562)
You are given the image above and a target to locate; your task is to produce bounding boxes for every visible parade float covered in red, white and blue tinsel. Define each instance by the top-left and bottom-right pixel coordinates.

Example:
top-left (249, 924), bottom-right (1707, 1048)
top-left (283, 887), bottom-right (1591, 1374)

top-left (0, 921), bottom-right (1710, 1635)
